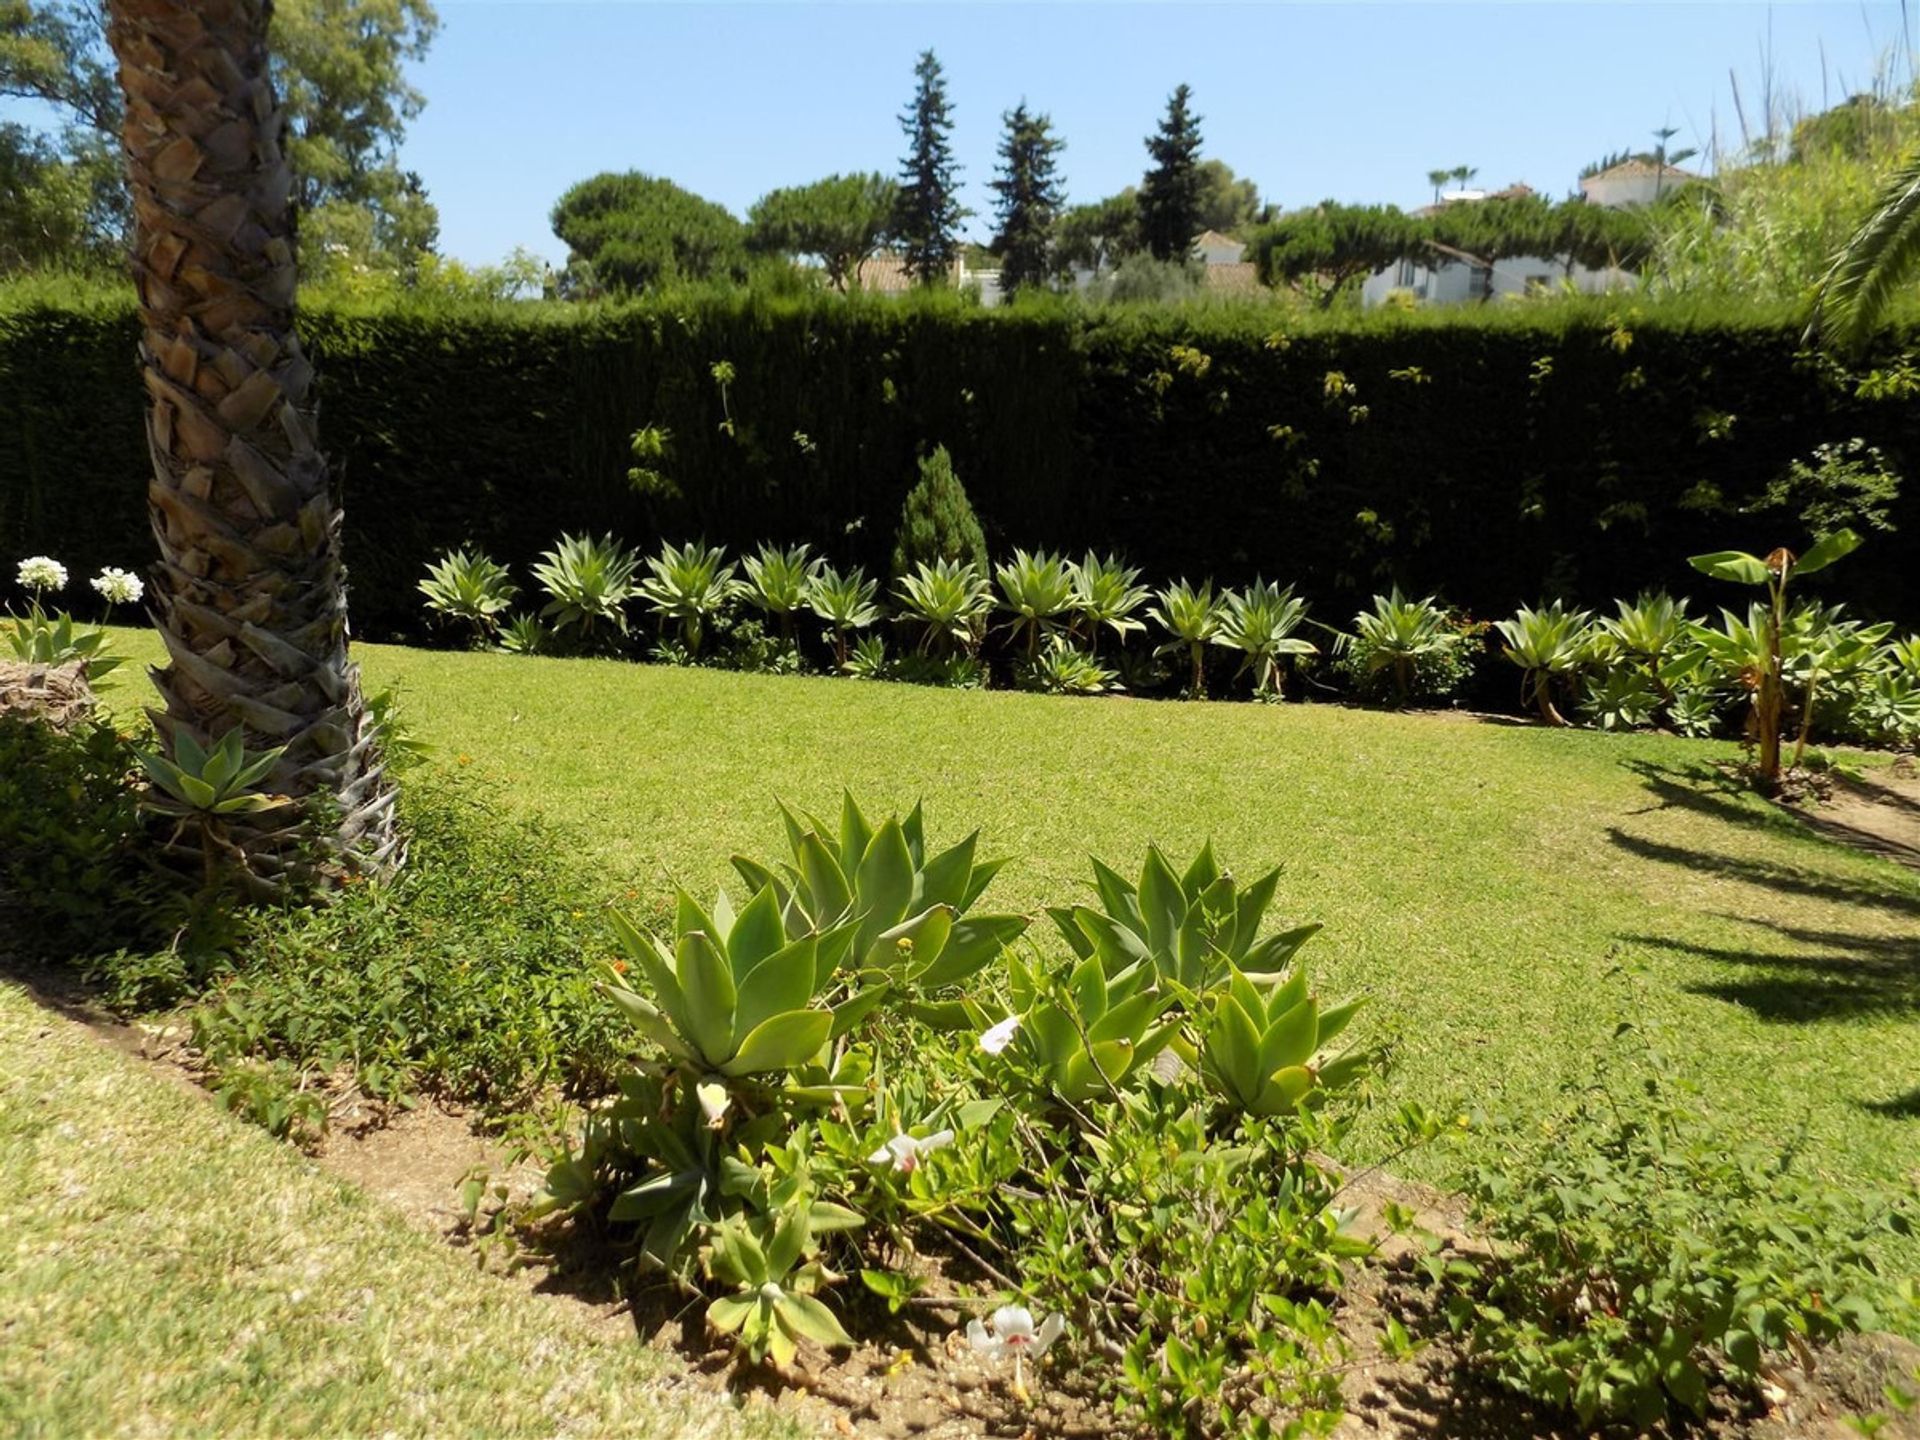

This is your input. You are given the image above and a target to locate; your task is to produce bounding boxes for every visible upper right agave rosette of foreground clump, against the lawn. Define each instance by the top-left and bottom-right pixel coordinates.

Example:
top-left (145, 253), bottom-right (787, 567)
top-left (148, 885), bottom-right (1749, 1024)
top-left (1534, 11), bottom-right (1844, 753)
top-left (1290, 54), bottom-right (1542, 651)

top-left (1046, 845), bottom-right (1319, 993)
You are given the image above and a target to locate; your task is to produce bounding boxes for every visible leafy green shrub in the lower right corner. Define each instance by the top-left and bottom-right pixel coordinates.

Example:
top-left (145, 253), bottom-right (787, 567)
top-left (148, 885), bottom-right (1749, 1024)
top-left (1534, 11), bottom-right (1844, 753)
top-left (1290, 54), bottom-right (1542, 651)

top-left (1434, 1027), bottom-right (1912, 1427)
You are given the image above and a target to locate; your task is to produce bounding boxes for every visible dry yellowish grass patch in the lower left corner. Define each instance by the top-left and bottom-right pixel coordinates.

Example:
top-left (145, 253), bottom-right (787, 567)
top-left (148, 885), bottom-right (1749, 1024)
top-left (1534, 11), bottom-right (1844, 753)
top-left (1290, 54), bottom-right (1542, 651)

top-left (0, 983), bottom-right (797, 1436)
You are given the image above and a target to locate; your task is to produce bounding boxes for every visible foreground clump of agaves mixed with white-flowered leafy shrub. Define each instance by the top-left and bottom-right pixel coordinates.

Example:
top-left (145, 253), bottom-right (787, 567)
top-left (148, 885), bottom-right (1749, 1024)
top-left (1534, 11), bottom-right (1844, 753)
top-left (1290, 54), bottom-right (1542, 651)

top-left (532, 797), bottom-right (1397, 1434)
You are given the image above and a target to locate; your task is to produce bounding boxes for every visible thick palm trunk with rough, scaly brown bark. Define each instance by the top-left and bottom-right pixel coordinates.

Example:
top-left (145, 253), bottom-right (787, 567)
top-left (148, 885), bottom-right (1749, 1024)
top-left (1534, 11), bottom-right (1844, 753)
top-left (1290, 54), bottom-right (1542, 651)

top-left (108, 0), bottom-right (396, 893)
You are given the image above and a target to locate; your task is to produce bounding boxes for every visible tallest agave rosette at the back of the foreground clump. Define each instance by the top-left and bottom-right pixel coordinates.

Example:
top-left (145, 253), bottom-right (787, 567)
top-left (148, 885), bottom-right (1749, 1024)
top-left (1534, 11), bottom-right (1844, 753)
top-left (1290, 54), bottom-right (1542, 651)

top-left (733, 795), bottom-right (1027, 1023)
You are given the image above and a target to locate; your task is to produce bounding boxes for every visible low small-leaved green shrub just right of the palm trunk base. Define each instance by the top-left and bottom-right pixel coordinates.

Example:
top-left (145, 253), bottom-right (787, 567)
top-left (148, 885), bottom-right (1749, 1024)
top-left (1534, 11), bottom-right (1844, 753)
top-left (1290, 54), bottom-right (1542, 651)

top-left (164, 770), bottom-right (622, 1108)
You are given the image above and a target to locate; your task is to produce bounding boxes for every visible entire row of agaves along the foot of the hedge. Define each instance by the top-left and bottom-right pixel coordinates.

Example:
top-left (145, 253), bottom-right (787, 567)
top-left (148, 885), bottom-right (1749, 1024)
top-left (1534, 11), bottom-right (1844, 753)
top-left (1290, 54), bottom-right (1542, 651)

top-left (420, 532), bottom-right (1920, 768)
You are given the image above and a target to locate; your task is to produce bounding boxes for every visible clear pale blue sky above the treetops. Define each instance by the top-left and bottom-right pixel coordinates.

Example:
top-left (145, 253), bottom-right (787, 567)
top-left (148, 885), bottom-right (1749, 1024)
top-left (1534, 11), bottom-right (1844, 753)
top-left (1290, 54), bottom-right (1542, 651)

top-left (403, 0), bottom-right (1905, 261)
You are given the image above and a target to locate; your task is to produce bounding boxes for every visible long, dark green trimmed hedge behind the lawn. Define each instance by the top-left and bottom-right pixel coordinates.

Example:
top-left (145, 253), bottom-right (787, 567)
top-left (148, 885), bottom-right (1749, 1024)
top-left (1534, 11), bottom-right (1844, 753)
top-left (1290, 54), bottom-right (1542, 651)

top-left (0, 296), bottom-right (1920, 637)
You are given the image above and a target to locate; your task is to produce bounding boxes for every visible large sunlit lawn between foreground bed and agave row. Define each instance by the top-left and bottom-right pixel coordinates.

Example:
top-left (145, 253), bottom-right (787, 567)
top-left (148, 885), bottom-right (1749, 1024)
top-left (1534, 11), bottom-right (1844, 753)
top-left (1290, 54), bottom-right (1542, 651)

top-left (101, 634), bottom-right (1920, 1221)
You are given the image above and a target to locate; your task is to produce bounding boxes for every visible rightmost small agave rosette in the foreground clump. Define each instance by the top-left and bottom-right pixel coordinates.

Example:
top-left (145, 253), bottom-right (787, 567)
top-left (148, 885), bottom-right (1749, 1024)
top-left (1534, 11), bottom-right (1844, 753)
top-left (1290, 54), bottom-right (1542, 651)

top-left (1200, 966), bottom-right (1365, 1116)
